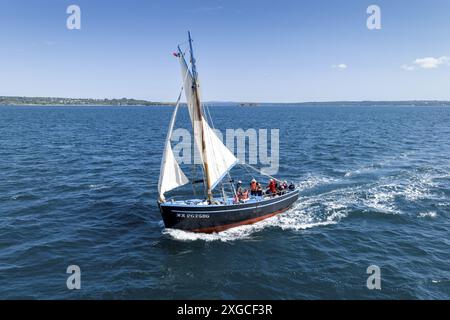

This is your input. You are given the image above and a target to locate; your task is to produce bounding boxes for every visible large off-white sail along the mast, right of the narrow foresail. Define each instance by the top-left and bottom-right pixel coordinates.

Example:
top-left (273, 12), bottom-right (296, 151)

top-left (178, 35), bottom-right (238, 199)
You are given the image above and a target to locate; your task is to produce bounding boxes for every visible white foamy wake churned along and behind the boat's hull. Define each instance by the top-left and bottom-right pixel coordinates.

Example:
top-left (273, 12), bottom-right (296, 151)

top-left (163, 164), bottom-right (446, 241)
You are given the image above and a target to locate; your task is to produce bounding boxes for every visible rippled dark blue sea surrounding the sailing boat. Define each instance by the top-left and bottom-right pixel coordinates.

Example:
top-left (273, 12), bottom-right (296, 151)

top-left (0, 105), bottom-right (450, 299)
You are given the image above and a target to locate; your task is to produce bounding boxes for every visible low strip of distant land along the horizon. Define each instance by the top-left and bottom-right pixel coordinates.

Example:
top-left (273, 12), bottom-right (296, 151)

top-left (0, 96), bottom-right (450, 107)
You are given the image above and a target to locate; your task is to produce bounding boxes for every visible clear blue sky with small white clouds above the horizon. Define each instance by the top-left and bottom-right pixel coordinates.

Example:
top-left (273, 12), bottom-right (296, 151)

top-left (0, 0), bottom-right (450, 102)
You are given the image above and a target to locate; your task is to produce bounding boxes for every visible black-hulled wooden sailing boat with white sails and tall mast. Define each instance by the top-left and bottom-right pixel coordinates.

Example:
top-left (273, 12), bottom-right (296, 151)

top-left (158, 33), bottom-right (299, 233)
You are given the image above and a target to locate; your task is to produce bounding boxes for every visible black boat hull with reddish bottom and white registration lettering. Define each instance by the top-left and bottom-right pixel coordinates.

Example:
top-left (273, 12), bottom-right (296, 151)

top-left (158, 190), bottom-right (299, 233)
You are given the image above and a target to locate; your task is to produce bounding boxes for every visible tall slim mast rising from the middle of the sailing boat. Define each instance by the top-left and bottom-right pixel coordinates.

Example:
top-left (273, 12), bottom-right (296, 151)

top-left (188, 31), bottom-right (212, 201)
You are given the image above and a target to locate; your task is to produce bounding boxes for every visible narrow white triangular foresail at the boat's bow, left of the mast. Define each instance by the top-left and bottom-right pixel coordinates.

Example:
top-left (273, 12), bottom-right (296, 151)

top-left (158, 92), bottom-right (189, 202)
